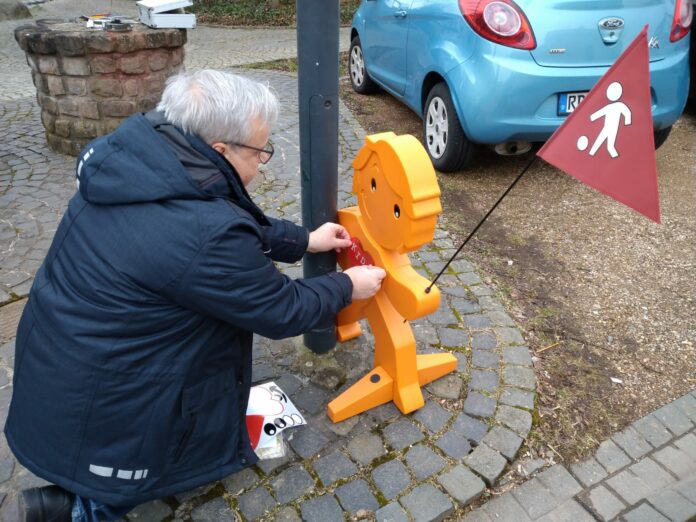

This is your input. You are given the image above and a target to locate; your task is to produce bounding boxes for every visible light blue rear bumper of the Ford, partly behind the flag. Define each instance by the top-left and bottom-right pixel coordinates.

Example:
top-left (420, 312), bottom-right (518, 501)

top-left (446, 46), bottom-right (689, 144)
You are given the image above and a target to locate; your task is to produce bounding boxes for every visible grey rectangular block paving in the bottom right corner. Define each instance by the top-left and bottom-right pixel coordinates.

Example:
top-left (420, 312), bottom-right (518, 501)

top-left (465, 392), bottom-right (696, 522)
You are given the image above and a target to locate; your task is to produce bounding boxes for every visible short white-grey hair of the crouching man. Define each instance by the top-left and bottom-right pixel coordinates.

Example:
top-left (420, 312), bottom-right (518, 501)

top-left (157, 69), bottom-right (278, 144)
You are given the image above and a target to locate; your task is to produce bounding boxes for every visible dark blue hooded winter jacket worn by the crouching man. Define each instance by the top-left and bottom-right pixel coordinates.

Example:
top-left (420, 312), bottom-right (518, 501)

top-left (5, 110), bottom-right (352, 505)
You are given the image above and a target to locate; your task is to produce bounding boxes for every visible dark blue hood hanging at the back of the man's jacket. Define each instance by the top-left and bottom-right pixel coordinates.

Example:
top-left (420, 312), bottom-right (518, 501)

top-left (76, 114), bottom-right (210, 205)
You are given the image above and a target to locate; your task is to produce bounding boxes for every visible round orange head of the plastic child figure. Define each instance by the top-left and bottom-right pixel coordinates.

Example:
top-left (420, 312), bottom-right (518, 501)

top-left (353, 132), bottom-right (442, 253)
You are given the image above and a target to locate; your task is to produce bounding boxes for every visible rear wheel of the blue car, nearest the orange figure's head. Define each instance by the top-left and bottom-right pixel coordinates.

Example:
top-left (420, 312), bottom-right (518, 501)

top-left (423, 82), bottom-right (474, 172)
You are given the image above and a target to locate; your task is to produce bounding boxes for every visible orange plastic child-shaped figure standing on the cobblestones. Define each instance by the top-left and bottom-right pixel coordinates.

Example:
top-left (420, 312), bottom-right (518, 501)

top-left (328, 132), bottom-right (457, 422)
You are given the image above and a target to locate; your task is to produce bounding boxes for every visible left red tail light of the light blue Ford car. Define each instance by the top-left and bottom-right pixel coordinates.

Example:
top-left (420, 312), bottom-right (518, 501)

top-left (459, 0), bottom-right (536, 50)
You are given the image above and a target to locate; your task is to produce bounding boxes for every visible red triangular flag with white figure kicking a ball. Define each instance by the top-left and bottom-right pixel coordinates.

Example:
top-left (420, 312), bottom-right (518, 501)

top-left (537, 26), bottom-right (660, 223)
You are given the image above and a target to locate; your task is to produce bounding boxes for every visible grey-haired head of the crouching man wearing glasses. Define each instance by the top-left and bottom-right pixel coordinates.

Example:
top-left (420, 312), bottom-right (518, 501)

top-left (157, 69), bottom-right (278, 185)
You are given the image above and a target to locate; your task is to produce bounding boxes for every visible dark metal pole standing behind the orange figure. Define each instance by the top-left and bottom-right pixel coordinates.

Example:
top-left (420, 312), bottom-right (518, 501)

top-left (296, 0), bottom-right (339, 353)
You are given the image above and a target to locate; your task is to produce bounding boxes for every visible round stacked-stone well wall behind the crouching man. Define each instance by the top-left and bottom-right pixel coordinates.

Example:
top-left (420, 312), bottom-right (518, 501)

top-left (15, 20), bottom-right (186, 156)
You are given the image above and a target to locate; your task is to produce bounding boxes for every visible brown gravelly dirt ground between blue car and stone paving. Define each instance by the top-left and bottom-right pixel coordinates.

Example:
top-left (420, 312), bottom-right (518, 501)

top-left (340, 77), bottom-right (696, 462)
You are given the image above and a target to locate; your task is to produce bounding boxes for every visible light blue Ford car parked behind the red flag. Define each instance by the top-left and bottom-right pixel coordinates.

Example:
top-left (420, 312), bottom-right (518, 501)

top-left (348, 0), bottom-right (693, 172)
